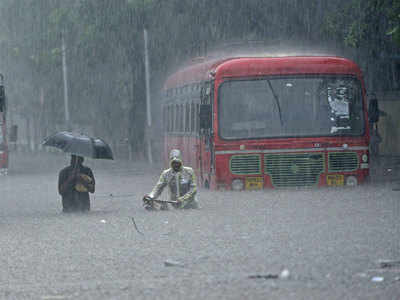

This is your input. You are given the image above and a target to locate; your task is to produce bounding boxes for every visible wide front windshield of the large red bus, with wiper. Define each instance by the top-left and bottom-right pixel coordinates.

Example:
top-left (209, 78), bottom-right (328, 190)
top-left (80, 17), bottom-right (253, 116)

top-left (218, 75), bottom-right (365, 139)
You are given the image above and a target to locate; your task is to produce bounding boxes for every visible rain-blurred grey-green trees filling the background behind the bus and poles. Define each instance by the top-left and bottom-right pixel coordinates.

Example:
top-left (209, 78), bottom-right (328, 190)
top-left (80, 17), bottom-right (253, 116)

top-left (0, 0), bottom-right (400, 155)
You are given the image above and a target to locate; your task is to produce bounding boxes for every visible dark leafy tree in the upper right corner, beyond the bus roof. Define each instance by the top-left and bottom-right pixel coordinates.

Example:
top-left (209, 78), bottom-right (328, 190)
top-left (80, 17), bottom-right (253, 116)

top-left (325, 0), bottom-right (400, 90)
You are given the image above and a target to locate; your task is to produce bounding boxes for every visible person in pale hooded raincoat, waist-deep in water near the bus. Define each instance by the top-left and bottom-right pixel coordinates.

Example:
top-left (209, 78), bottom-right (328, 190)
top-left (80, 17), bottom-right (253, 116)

top-left (143, 149), bottom-right (199, 210)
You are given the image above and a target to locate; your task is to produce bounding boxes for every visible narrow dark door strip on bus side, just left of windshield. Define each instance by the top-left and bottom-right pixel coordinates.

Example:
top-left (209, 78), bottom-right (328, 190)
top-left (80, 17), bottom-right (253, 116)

top-left (197, 81), bottom-right (214, 188)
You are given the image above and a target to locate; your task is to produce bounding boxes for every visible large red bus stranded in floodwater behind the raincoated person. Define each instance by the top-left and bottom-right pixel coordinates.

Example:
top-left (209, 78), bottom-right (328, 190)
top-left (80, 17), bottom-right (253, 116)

top-left (163, 56), bottom-right (369, 190)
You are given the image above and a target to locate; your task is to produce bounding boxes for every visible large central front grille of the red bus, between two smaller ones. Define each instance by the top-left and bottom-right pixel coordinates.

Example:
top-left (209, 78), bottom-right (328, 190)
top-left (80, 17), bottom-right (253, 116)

top-left (264, 153), bottom-right (325, 187)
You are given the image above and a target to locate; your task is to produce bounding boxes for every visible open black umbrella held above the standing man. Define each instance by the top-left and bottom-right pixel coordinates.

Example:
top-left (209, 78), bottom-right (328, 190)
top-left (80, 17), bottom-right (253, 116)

top-left (43, 131), bottom-right (113, 159)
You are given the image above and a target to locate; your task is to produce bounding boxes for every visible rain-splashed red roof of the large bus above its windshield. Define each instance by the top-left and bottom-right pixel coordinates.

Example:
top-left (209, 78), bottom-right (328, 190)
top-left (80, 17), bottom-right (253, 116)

top-left (164, 56), bottom-right (361, 89)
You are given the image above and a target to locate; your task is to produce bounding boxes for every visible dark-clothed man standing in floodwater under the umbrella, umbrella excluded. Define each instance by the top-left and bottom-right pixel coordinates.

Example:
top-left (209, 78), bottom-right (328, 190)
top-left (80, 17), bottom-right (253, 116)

top-left (58, 155), bottom-right (95, 212)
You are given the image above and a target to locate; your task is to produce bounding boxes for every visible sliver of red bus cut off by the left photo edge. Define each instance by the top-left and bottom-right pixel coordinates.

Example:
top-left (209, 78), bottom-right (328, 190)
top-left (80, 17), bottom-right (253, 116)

top-left (0, 74), bottom-right (8, 175)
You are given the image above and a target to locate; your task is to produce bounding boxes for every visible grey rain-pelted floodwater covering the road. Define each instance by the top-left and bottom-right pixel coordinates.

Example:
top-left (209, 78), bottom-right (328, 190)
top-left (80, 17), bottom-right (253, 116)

top-left (0, 154), bottom-right (400, 299)
